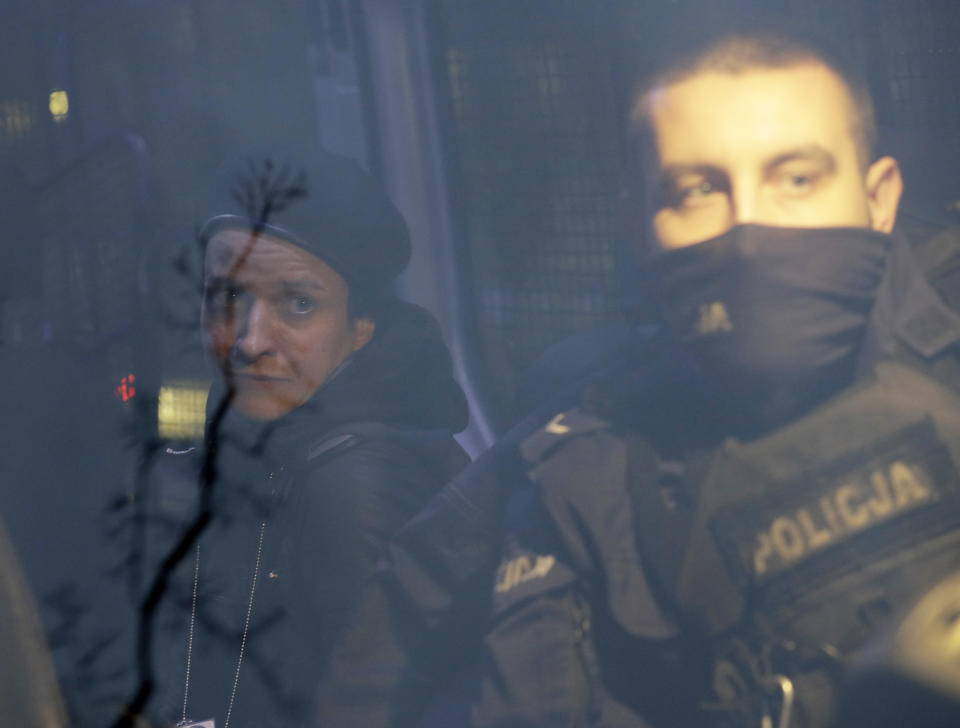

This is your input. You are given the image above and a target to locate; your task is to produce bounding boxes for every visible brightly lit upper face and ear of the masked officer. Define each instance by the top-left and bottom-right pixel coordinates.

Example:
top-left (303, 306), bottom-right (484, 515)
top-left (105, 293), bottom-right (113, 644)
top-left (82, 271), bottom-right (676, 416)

top-left (646, 61), bottom-right (902, 248)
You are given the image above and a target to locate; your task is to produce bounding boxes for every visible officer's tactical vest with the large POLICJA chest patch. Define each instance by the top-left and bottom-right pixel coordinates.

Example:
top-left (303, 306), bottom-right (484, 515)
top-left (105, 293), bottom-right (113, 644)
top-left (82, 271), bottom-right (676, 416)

top-left (628, 362), bottom-right (960, 728)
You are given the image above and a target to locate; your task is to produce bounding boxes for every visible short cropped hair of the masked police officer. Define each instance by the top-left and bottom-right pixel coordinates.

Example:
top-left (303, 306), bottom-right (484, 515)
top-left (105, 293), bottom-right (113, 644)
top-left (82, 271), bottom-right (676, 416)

top-left (630, 30), bottom-right (877, 170)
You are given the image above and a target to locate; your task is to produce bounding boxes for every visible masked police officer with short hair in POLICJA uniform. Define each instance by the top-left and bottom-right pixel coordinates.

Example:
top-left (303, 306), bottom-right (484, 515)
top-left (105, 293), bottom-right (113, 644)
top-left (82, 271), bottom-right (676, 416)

top-left (320, 28), bottom-right (960, 726)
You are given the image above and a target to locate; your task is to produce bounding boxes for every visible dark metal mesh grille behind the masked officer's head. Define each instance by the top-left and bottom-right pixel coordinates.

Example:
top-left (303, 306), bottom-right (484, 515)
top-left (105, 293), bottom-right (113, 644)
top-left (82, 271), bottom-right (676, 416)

top-left (437, 0), bottom-right (960, 424)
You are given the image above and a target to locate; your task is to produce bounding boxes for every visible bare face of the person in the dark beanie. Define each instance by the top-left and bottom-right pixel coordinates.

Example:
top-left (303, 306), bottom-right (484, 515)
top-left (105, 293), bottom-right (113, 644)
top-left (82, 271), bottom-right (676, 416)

top-left (203, 230), bottom-right (374, 420)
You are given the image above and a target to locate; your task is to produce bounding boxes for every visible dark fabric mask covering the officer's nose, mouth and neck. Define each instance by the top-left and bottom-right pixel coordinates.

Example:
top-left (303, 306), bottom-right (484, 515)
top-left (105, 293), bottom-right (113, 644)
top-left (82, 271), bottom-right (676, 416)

top-left (649, 225), bottom-right (891, 436)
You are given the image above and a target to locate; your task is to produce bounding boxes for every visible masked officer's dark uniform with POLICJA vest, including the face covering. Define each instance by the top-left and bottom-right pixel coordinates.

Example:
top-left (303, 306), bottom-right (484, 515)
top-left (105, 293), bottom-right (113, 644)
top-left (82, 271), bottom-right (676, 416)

top-left (471, 226), bottom-right (960, 726)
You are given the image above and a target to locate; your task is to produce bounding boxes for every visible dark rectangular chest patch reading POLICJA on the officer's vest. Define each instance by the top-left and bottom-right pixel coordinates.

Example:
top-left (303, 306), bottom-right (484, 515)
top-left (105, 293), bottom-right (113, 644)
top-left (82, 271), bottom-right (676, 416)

top-left (711, 421), bottom-right (960, 585)
